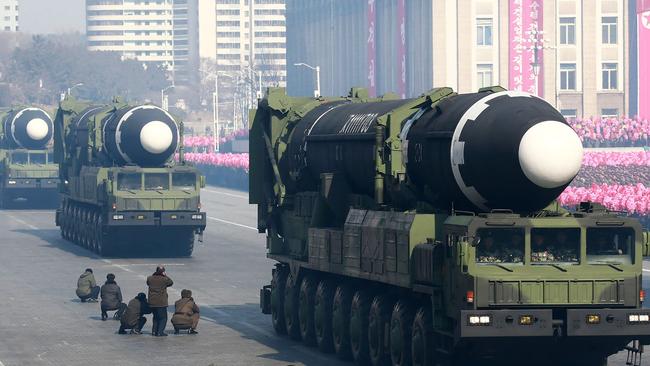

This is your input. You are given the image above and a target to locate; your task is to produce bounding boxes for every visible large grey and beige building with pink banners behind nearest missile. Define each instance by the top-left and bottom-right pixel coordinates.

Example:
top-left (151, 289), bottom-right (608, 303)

top-left (287, 0), bottom-right (633, 117)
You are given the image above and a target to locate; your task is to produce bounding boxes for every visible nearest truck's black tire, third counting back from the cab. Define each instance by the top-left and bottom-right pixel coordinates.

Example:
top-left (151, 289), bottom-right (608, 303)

top-left (368, 295), bottom-right (393, 366)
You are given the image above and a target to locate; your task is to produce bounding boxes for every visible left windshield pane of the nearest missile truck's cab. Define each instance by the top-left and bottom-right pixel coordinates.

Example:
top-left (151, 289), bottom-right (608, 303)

top-left (476, 228), bottom-right (524, 264)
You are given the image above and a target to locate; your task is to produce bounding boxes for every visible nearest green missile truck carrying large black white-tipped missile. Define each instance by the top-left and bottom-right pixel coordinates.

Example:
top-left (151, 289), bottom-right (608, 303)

top-left (250, 87), bottom-right (650, 365)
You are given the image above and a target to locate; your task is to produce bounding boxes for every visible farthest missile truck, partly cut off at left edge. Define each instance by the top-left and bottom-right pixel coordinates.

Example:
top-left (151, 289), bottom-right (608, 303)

top-left (0, 107), bottom-right (59, 207)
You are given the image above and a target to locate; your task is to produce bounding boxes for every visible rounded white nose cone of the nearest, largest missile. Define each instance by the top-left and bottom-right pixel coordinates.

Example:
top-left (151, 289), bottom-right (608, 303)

top-left (519, 121), bottom-right (582, 188)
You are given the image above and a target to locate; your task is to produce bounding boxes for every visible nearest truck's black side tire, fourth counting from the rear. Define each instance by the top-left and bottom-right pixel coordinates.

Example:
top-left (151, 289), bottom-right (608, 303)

top-left (314, 280), bottom-right (336, 353)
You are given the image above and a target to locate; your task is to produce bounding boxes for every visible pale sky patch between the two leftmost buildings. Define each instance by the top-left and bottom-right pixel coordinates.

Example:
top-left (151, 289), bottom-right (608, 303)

top-left (19, 0), bottom-right (85, 33)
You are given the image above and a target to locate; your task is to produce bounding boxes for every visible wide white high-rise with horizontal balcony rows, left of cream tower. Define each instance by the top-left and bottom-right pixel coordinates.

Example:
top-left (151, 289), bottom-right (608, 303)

top-left (86, 0), bottom-right (198, 83)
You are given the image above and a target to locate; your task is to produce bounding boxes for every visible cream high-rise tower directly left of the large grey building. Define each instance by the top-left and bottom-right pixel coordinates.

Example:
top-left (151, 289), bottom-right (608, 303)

top-left (199, 0), bottom-right (286, 86)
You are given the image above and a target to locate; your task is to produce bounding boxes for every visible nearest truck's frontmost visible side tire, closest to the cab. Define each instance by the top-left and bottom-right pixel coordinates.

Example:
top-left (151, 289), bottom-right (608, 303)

top-left (411, 306), bottom-right (435, 366)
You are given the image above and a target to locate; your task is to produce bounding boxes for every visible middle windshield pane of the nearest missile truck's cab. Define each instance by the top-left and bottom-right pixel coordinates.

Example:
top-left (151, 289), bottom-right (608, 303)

top-left (530, 228), bottom-right (580, 264)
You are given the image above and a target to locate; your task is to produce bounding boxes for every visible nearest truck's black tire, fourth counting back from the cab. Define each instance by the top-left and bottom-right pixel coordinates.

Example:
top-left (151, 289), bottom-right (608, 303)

top-left (350, 290), bottom-right (371, 365)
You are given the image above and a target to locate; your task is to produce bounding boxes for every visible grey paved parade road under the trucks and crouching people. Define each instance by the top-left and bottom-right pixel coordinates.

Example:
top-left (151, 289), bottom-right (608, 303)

top-left (0, 188), bottom-right (650, 366)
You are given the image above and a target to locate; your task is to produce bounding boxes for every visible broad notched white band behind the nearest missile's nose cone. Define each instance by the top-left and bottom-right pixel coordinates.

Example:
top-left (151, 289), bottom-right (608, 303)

top-left (450, 90), bottom-right (534, 211)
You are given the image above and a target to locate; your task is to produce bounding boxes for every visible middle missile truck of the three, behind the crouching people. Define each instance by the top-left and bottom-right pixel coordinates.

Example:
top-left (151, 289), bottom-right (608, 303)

top-left (54, 97), bottom-right (206, 256)
